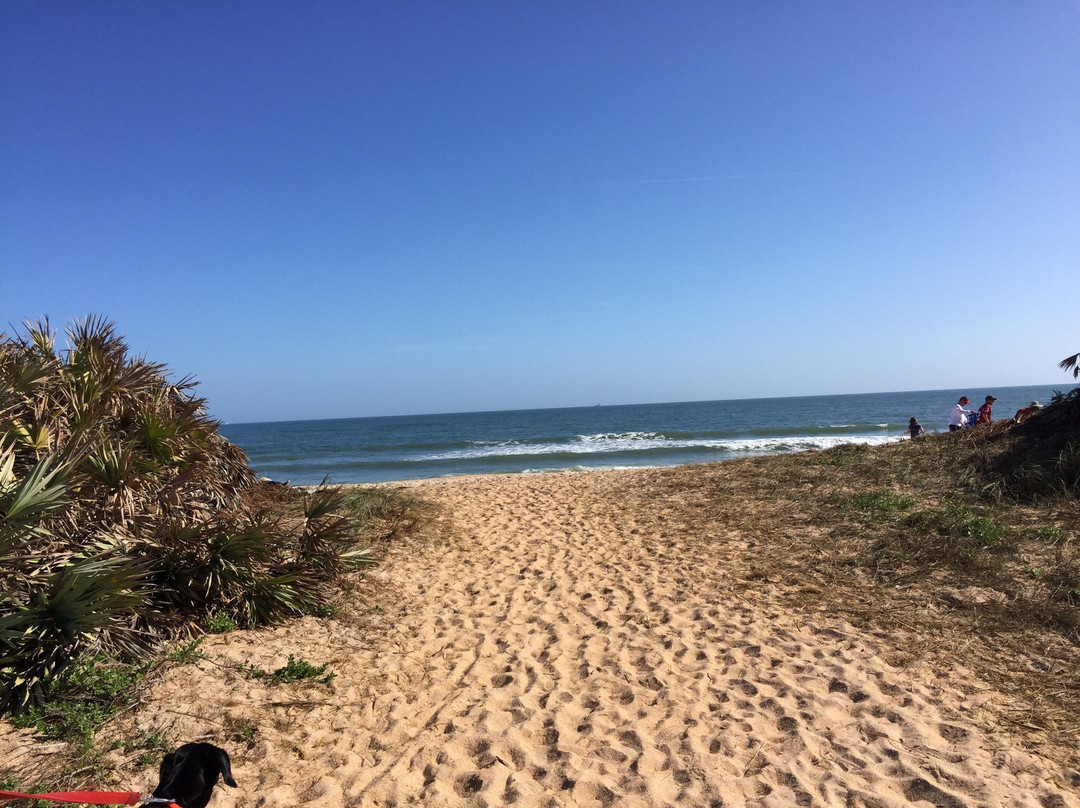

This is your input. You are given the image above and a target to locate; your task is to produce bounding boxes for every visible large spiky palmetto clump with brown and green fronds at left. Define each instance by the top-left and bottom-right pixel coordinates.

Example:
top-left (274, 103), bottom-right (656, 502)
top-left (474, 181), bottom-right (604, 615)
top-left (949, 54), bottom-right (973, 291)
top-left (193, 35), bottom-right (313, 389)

top-left (0, 317), bottom-right (367, 710)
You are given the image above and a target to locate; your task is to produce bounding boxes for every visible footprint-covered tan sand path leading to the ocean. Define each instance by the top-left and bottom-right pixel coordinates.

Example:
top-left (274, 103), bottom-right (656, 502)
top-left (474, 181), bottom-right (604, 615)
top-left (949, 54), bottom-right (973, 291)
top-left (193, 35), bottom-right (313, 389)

top-left (6, 470), bottom-right (1080, 808)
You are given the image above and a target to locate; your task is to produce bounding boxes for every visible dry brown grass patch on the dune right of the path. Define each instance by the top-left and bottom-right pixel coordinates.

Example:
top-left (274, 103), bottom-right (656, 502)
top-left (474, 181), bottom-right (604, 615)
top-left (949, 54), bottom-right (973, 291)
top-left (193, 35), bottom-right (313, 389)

top-left (635, 418), bottom-right (1080, 767)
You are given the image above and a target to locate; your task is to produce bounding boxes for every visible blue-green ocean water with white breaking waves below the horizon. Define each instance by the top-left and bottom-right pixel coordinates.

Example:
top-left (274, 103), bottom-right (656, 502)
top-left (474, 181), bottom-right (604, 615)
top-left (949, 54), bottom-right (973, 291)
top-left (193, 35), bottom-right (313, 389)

top-left (221, 385), bottom-right (1068, 485)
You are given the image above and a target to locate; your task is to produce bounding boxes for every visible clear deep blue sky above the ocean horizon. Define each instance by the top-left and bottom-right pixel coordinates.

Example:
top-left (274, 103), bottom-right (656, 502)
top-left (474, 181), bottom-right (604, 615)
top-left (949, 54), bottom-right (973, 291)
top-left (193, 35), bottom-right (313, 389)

top-left (0, 0), bottom-right (1080, 422)
